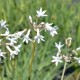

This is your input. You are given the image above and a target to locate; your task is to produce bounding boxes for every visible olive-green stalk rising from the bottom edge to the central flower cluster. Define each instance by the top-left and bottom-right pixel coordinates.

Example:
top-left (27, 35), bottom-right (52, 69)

top-left (28, 42), bottom-right (35, 80)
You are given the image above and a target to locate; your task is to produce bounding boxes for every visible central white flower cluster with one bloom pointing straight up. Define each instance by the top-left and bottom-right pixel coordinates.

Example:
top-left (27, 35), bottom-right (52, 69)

top-left (29, 7), bottom-right (58, 43)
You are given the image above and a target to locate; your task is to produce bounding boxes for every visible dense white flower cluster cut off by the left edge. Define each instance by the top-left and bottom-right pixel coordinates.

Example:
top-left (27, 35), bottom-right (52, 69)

top-left (0, 20), bottom-right (26, 62)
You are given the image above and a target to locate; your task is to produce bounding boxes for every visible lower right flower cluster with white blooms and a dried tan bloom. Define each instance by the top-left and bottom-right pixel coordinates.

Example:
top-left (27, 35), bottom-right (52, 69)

top-left (52, 37), bottom-right (80, 66)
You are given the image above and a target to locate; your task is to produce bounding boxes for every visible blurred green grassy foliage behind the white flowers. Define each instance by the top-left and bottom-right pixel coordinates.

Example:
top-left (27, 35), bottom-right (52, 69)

top-left (0, 0), bottom-right (80, 80)
